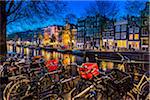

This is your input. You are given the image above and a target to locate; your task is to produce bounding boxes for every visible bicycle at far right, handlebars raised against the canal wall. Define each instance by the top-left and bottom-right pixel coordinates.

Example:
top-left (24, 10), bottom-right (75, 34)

top-left (95, 53), bottom-right (150, 100)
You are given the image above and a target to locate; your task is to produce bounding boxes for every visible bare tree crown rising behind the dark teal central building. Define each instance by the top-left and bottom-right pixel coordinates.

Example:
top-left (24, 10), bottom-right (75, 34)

top-left (85, 0), bottom-right (119, 19)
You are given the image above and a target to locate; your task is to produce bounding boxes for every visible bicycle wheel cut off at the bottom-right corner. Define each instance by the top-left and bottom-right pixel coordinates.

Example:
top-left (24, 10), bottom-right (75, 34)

top-left (140, 81), bottom-right (150, 100)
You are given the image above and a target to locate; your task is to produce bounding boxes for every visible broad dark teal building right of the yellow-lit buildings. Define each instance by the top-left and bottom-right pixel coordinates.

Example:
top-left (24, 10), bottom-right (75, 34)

top-left (77, 15), bottom-right (101, 49)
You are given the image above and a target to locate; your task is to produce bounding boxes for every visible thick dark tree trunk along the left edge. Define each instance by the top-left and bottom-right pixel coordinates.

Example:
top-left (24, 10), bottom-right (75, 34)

top-left (0, 0), bottom-right (7, 58)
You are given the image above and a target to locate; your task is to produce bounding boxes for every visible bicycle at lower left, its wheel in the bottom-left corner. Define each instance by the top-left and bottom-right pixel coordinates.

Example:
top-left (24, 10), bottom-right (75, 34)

top-left (3, 55), bottom-right (77, 100)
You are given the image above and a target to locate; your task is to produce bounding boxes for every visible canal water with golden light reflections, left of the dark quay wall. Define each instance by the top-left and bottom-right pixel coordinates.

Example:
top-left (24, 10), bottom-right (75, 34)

top-left (7, 45), bottom-right (84, 65)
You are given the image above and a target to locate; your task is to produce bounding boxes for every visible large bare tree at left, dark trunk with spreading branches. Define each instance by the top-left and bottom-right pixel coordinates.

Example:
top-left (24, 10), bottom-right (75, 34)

top-left (0, 0), bottom-right (66, 56)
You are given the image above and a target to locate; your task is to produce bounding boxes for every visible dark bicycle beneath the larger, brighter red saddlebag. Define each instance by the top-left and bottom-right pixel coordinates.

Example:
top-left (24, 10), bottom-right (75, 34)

top-left (72, 62), bottom-right (132, 100)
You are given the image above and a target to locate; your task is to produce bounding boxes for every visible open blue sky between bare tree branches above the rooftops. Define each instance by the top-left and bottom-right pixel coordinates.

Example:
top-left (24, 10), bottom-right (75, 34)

top-left (7, 0), bottom-right (146, 34)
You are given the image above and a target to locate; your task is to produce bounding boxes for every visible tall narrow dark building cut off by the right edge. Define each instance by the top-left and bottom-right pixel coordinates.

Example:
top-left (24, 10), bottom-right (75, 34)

top-left (140, 2), bottom-right (150, 51)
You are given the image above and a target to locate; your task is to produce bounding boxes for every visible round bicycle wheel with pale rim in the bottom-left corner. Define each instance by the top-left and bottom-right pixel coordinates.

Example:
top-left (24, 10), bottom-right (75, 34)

top-left (7, 79), bottom-right (30, 100)
